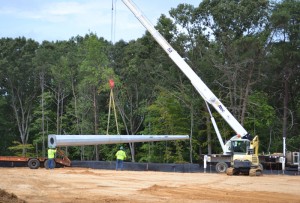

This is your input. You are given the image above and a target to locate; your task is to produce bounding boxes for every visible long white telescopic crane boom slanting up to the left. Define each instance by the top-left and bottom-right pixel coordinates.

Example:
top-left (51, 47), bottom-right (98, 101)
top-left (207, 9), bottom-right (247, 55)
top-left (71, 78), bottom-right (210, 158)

top-left (122, 0), bottom-right (248, 149)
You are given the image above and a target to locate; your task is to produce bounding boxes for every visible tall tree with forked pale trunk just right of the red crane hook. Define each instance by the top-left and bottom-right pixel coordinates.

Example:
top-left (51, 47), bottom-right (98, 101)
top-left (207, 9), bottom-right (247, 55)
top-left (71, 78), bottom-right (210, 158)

top-left (112, 36), bottom-right (156, 162)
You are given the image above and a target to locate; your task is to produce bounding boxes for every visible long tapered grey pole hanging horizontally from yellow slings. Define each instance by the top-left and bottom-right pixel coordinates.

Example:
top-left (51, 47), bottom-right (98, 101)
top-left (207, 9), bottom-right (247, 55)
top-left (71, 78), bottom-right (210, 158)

top-left (48, 135), bottom-right (189, 148)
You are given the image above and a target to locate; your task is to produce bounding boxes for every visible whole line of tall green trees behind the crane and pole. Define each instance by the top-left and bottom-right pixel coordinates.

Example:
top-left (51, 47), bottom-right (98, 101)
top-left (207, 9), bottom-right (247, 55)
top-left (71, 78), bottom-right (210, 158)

top-left (0, 0), bottom-right (300, 163)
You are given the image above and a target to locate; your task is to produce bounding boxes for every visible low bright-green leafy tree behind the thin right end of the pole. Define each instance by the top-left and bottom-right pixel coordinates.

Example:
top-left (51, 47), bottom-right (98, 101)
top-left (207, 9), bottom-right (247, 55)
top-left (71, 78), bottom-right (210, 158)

top-left (140, 90), bottom-right (190, 163)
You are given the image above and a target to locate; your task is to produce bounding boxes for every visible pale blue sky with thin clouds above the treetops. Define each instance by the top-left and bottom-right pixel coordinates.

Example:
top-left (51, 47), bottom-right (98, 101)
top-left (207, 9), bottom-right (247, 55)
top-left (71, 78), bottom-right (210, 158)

top-left (0, 0), bottom-right (201, 42)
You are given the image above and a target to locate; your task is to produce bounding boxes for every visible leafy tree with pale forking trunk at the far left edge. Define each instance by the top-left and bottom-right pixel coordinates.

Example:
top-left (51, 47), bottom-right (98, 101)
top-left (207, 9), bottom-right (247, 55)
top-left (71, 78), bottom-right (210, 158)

top-left (0, 38), bottom-right (38, 155)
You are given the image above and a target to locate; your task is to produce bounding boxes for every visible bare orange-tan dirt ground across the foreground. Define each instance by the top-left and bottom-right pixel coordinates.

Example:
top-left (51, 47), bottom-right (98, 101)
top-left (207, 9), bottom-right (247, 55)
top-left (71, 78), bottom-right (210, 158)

top-left (0, 167), bottom-right (300, 203)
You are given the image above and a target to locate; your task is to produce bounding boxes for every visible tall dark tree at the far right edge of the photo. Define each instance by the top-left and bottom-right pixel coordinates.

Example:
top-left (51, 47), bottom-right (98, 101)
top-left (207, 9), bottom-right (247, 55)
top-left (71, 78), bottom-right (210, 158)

top-left (269, 0), bottom-right (300, 151)
